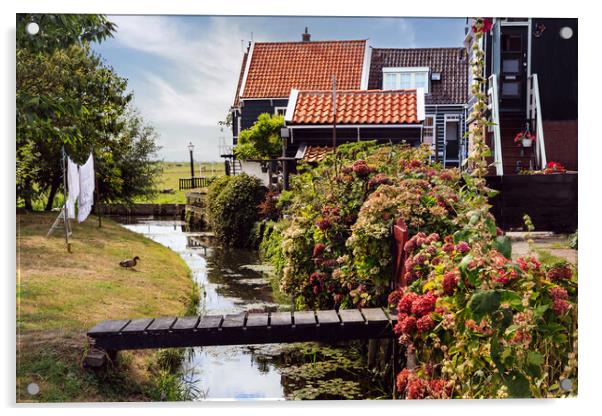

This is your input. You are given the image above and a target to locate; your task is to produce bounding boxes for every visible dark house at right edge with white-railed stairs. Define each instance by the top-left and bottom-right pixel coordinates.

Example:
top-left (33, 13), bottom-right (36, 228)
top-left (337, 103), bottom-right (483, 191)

top-left (466, 18), bottom-right (578, 175)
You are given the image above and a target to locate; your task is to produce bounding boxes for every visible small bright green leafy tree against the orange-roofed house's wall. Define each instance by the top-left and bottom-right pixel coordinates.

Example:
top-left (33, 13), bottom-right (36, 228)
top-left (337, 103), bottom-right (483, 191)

top-left (234, 113), bottom-right (284, 160)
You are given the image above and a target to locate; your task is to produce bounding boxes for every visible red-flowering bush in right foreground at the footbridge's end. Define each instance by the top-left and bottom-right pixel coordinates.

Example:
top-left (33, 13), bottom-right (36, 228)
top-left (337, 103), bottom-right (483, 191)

top-left (389, 233), bottom-right (577, 399)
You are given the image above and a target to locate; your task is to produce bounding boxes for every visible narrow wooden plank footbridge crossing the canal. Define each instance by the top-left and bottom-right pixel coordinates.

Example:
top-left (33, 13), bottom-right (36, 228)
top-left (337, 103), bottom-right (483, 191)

top-left (87, 308), bottom-right (397, 365)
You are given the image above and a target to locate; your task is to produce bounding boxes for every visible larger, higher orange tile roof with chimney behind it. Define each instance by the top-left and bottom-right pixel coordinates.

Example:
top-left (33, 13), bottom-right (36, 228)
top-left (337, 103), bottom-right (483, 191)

top-left (241, 40), bottom-right (367, 98)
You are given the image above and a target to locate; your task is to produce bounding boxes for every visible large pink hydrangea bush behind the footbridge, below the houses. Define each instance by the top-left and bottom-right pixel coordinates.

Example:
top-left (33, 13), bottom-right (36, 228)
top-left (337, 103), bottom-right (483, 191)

top-left (262, 142), bottom-right (495, 308)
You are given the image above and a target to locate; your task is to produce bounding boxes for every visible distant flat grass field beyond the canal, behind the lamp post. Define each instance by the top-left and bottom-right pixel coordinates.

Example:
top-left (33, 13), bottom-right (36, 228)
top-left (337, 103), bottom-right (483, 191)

top-left (136, 162), bottom-right (224, 204)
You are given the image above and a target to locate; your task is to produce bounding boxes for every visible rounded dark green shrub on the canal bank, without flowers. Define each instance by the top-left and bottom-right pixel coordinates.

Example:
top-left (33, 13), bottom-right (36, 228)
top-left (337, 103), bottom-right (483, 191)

top-left (207, 173), bottom-right (265, 247)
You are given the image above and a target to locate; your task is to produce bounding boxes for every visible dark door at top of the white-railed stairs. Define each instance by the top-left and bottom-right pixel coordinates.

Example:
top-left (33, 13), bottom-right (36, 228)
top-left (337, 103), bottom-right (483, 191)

top-left (500, 26), bottom-right (528, 111)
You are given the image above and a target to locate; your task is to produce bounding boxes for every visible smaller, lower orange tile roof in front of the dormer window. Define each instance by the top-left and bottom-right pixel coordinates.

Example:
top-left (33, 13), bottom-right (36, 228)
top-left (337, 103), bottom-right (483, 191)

top-left (287, 90), bottom-right (424, 124)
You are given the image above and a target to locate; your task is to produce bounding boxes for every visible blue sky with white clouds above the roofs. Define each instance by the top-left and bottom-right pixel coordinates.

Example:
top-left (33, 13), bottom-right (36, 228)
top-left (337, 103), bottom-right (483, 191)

top-left (94, 15), bottom-right (465, 161)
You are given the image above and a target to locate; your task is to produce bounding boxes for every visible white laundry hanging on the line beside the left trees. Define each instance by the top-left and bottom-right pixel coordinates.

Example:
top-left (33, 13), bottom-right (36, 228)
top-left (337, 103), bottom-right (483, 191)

top-left (66, 153), bottom-right (94, 222)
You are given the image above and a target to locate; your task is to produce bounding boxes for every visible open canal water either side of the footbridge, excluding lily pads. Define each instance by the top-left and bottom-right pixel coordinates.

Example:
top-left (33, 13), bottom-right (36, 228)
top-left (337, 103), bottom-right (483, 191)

top-left (123, 220), bottom-right (284, 400)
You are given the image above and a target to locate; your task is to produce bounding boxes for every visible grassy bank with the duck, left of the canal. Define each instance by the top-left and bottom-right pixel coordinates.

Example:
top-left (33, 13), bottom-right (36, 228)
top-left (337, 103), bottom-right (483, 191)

top-left (17, 213), bottom-right (198, 402)
